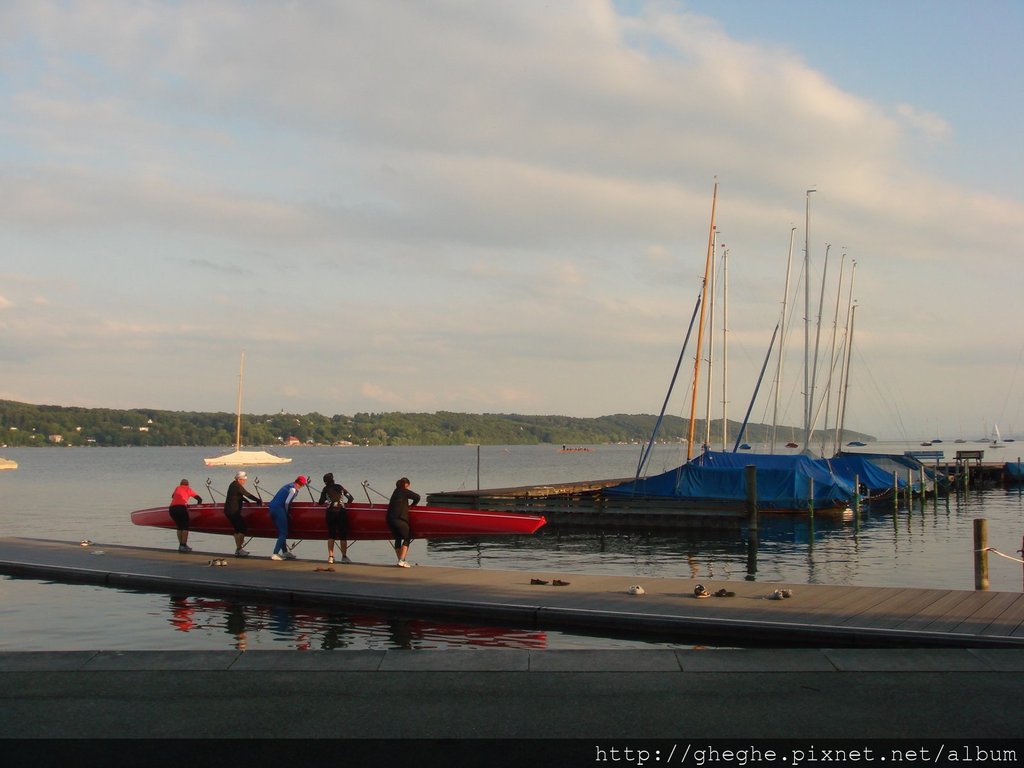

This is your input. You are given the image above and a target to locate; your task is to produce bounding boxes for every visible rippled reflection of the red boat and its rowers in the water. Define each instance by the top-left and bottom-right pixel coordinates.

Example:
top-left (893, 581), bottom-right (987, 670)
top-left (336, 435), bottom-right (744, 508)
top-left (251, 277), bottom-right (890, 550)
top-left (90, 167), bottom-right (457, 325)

top-left (157, 594), bottom-right (548, 650)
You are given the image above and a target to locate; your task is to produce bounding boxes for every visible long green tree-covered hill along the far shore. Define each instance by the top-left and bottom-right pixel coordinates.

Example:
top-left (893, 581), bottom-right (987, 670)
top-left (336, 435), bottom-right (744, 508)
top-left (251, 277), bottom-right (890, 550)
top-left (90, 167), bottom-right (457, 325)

top-left (0, 400), bottom-right (870, 445)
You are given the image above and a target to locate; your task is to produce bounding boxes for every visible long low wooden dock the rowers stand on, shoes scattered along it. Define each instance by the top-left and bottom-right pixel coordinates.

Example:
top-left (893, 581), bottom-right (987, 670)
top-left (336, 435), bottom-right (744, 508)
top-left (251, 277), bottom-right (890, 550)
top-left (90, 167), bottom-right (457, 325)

top-left (0, 538), bottom-right (1024, 648)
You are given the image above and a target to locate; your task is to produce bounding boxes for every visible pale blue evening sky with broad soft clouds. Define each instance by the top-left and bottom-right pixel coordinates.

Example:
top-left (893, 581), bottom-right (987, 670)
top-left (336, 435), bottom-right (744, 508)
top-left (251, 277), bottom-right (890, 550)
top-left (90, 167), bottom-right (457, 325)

top-left (0, 0), bottom-right (1024, 439)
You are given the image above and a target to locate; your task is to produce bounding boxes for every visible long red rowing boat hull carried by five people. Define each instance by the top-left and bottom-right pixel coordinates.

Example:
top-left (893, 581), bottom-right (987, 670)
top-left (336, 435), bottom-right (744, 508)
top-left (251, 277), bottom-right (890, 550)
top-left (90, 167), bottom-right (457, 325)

top-left (131, 502), bottom-right (547, 540)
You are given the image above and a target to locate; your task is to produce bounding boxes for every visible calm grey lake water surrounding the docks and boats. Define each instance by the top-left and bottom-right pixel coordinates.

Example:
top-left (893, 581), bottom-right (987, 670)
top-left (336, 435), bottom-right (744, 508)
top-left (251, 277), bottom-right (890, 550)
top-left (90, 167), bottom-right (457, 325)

top-left (0, 443), bottom-right (1024, 650)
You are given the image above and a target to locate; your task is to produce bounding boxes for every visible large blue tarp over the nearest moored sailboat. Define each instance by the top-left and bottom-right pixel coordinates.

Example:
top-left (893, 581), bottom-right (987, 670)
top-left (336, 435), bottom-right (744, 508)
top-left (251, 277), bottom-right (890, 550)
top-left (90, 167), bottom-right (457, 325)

top-left (602, 451), bottom-right (854, 509)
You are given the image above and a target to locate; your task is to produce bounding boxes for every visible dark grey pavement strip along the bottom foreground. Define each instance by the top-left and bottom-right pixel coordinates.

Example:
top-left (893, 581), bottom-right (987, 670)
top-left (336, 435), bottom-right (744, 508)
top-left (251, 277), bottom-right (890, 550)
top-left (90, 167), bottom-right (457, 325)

top-left (0, 649), bottom-right (1024, 762)
